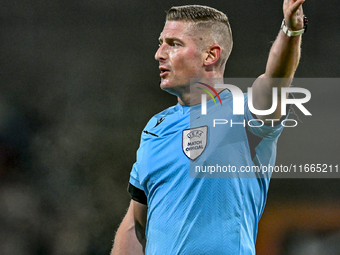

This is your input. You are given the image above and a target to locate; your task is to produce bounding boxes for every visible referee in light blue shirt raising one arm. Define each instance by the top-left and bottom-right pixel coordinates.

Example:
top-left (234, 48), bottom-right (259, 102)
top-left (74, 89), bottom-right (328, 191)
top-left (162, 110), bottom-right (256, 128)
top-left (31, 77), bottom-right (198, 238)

top-left (111, 0), bottom-right (306, 255)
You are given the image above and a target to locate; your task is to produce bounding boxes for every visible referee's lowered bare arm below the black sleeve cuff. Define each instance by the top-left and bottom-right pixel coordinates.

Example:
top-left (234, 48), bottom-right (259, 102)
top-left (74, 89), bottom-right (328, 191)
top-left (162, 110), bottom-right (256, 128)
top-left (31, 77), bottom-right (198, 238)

top-left (111, 200), bottom-right (147, 255)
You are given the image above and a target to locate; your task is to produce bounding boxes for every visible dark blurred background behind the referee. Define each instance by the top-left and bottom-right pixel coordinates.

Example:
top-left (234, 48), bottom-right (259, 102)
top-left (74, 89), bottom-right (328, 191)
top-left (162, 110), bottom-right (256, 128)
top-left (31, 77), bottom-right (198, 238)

top-left (0, 0), bottom-right (340, 255)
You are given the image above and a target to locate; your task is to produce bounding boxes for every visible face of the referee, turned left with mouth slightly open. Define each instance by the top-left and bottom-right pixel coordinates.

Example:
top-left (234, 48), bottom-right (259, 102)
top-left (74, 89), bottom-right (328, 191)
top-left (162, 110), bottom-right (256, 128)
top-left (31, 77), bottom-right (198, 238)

top-left (155, 21), bottom-right (204, 95)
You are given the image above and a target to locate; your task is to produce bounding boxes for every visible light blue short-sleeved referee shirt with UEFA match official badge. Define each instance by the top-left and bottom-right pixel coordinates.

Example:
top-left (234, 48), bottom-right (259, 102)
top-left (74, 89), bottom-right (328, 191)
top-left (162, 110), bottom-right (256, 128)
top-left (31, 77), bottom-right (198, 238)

top-left (130, 90), bottom-right (283, 255)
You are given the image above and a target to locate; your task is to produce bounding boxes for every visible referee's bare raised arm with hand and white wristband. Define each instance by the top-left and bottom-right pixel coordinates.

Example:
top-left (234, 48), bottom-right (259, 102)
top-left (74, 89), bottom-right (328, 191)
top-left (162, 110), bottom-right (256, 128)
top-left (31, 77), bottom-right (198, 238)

top-left (253, 0), bottom-right (305, 120)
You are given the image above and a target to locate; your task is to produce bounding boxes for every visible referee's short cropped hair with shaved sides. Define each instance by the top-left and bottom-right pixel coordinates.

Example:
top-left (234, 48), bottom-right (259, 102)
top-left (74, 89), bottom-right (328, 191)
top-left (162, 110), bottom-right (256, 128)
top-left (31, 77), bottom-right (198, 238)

top-left (166, 5), bottom-right (233, 65)
